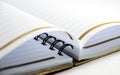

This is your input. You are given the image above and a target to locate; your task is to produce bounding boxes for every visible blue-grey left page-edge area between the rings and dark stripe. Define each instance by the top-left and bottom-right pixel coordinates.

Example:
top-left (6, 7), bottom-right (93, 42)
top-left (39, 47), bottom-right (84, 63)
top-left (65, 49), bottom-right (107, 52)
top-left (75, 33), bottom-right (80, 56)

top-left (0, 39), bottom-right (55, 68)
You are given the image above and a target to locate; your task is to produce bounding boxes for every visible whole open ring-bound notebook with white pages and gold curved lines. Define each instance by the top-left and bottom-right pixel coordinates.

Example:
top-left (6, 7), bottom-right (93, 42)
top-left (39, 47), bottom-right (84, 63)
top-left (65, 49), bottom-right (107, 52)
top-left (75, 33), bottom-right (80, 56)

top-left (0, 0), bottom-right (120, 75)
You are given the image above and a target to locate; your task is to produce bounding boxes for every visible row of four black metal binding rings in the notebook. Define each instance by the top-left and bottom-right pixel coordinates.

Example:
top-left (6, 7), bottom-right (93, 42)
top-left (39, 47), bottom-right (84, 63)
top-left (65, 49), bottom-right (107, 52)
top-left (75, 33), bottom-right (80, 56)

top-left (34, 33), bottom-right (74, 56)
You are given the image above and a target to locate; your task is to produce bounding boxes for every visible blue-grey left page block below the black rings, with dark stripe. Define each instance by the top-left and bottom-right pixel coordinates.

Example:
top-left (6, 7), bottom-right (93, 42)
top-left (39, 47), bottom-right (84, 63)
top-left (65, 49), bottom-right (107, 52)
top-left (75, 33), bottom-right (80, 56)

top-left (0, 38), bottom-right (72, 75)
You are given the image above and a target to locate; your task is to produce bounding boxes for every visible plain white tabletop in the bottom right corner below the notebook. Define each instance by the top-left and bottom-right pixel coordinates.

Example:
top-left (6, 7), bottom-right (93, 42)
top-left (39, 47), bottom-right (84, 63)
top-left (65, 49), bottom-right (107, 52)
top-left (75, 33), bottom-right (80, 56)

top-left (56, 52), bottom-right (120, 75)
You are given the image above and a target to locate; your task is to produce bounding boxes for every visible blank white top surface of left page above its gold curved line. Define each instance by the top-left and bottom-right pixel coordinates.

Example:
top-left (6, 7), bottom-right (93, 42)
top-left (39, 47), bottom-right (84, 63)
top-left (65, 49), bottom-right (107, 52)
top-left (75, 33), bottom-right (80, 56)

top-left (0, 1), bottom-right (52, 49)
